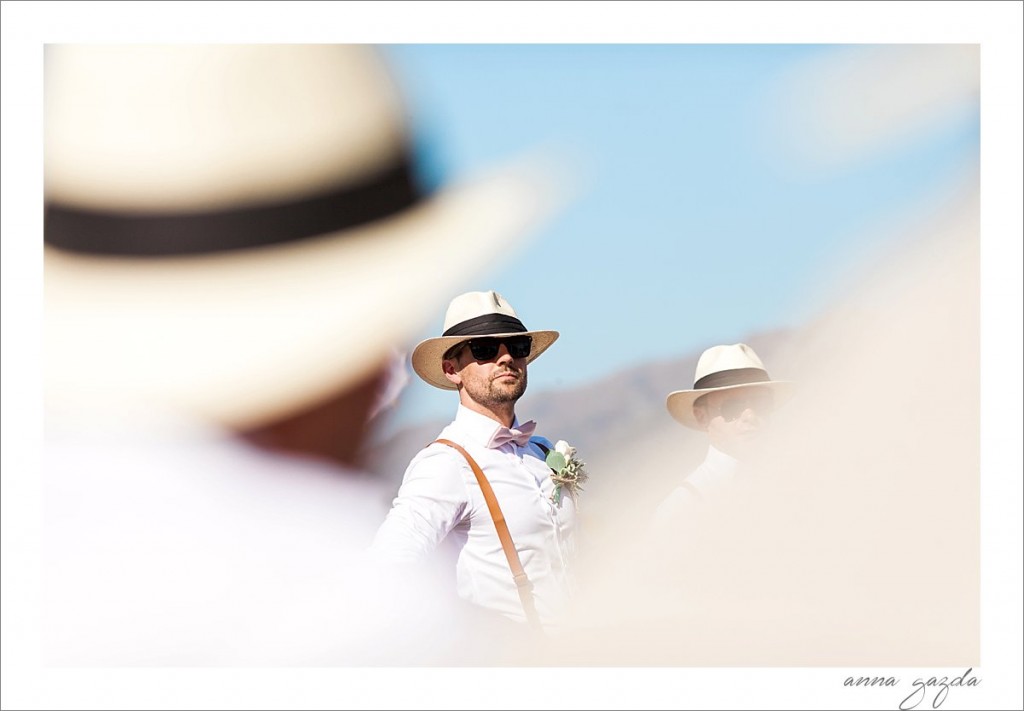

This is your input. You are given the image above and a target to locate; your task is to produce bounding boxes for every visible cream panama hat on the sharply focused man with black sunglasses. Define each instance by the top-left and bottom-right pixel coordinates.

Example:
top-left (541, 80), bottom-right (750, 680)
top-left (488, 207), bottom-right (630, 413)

top-left (413, 291), bottom-right (558, 390)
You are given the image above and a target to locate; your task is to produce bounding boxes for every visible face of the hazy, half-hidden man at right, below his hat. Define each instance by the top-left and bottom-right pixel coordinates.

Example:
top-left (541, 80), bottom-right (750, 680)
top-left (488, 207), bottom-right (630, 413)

top-left (693, 386), bottom-right (774, 459)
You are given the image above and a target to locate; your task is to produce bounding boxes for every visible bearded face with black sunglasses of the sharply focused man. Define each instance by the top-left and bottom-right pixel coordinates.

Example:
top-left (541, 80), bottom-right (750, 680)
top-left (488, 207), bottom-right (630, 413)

top-left (443, 336), bottom-right (529, 410)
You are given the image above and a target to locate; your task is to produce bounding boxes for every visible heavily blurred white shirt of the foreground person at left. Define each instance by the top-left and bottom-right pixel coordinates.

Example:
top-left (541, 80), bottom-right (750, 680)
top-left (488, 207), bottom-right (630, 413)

top-left (41, 411), bottom-right (464, 666)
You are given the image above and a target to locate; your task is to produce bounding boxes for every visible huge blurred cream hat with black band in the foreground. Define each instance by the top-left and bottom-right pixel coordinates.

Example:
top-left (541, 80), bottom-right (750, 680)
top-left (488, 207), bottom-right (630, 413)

top-left (44, 44), bottom-right (552, 427)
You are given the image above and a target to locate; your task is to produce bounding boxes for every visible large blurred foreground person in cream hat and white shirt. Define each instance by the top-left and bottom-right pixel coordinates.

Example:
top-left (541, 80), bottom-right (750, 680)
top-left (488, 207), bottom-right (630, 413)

top-left (42, 44), bottom-right (561, 666)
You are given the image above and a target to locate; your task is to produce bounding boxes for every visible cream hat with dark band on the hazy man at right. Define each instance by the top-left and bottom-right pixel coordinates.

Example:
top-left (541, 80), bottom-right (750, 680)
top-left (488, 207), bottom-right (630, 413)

top-left (666, 343), bottom-right (793, 429)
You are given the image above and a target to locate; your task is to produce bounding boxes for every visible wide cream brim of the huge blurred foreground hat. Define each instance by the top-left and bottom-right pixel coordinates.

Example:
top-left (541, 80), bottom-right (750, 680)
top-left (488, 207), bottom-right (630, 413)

top-left (44, 164), bottom-right (553, 427)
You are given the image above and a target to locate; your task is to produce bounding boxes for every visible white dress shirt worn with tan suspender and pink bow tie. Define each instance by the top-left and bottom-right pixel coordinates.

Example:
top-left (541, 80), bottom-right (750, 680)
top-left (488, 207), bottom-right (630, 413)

top-left (371, 405), bottom-right (577, 625)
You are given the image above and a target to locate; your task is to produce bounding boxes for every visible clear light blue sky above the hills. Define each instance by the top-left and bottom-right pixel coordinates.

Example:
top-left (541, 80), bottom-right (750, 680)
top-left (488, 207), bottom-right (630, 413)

top-left (384, 44), bottom-right (979, 424)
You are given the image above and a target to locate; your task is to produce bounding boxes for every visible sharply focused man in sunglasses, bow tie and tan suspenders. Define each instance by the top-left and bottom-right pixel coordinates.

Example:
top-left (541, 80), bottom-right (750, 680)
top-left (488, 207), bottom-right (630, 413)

top-left (372, 291), bottom-right (582, 627)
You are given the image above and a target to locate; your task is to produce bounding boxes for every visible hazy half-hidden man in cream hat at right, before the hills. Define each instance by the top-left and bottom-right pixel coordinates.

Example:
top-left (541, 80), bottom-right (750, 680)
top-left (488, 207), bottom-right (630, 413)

top-left (655, 343), bottom-right (791, 525)
